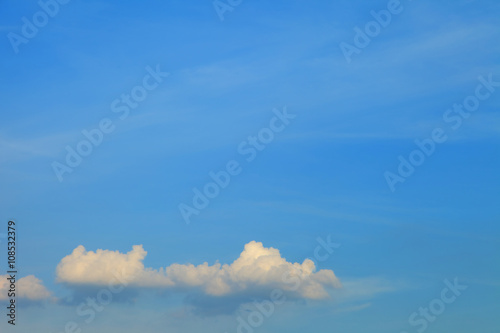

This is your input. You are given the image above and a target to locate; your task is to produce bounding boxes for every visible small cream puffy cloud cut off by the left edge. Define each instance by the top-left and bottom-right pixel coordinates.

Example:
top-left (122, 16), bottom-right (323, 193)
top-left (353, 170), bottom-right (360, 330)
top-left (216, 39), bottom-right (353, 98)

top-left (0, 275), bottom-right (51, 301)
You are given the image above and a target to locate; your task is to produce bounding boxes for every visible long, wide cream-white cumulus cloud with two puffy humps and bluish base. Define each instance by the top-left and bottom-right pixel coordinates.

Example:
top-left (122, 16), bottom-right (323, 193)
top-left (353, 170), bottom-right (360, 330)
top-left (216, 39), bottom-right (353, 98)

top-left (57, 241), bottom-right (340, 299)
